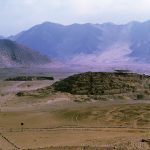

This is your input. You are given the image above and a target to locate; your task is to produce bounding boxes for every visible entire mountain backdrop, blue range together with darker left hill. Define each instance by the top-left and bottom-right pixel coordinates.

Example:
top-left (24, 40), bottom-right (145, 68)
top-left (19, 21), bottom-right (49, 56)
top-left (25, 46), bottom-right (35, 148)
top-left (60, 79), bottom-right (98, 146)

top-left (0, 21), bottom-right (150, 67)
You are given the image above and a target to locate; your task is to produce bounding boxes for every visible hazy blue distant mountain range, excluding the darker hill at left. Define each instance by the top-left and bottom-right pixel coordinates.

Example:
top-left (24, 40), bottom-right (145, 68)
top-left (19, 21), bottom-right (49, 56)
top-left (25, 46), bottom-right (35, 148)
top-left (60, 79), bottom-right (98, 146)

top-left (9, 21), bottom-right (150, 64)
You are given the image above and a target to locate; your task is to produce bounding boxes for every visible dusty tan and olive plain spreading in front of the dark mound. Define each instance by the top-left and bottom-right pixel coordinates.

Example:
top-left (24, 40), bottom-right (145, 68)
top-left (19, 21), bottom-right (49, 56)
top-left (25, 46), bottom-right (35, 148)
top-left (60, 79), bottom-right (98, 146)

top-left (0, 78), bottom-right (150, 150)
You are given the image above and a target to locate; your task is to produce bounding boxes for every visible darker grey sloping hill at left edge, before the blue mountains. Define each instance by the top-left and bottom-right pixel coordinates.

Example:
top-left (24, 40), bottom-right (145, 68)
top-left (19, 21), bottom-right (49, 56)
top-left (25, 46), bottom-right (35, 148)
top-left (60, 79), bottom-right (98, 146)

top-left (0, 39), bottom-right (50, 67)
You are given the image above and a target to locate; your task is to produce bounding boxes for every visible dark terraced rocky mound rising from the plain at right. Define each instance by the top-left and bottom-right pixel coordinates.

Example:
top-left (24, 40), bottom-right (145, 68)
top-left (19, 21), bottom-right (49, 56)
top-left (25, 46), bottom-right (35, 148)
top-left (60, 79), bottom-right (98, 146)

top-left (52, 72), bottom-right (150, 99)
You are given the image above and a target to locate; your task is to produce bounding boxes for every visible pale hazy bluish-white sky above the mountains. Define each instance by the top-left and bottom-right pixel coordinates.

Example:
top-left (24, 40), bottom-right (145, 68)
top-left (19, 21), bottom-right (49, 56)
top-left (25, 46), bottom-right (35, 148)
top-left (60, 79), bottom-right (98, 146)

top-left (0, 0), bottom-right (150, 35)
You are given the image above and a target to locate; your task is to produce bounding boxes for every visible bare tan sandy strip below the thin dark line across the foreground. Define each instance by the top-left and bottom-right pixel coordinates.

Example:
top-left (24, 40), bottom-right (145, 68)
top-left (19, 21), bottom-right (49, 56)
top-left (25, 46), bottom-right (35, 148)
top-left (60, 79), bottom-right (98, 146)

top-left (3, 129), bottom-right (150, 150)
